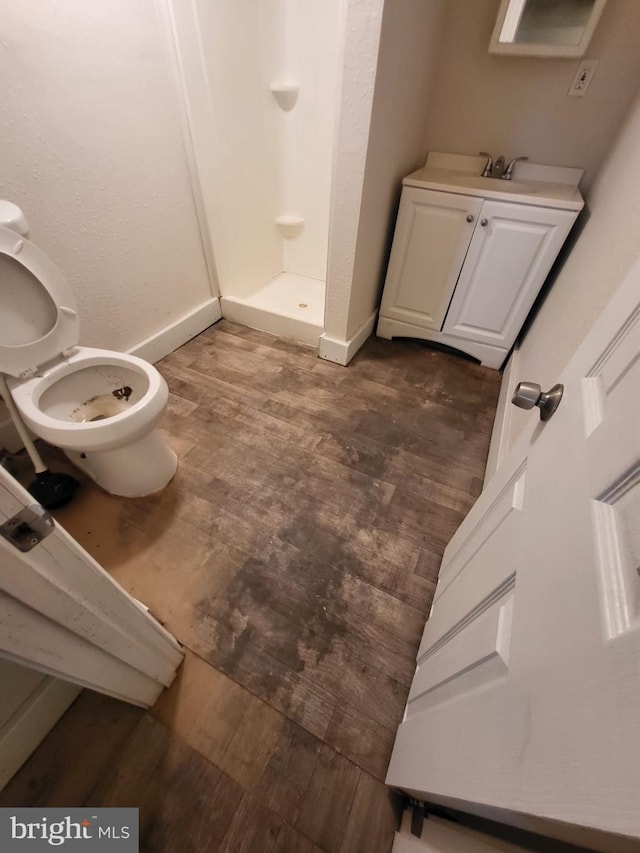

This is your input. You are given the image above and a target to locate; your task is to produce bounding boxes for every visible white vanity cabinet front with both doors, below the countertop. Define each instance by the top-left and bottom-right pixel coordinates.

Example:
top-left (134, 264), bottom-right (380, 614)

top-left (377, 186), bottom-right (577, 368)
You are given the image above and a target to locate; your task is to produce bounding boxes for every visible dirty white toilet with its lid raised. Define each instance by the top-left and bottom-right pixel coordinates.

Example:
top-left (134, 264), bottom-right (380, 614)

top-left (0, 201), bottom-right (177, 497)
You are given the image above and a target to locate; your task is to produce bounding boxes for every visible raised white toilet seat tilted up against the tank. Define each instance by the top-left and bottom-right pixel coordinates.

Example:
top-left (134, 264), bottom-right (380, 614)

top-left (0, 226), bottom-right (80, 377)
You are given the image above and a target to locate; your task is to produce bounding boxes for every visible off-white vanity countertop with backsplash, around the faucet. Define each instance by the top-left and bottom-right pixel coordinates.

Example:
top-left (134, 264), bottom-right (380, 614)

top-left (402, 152), bottom-right (584, 211)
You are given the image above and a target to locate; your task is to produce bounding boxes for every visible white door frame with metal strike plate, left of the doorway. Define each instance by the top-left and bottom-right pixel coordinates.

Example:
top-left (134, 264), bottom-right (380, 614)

top-left (0, 466), bottom-right (183, 707)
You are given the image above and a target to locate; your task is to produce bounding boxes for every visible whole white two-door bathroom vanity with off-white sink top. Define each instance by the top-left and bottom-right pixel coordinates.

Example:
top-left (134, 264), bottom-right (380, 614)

top-left (377, 152), bottom-right (584, 368)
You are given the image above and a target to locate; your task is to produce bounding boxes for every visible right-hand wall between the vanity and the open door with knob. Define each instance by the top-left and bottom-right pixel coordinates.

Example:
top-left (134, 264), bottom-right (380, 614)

top-left (497, 88), bottom-right (640, 448)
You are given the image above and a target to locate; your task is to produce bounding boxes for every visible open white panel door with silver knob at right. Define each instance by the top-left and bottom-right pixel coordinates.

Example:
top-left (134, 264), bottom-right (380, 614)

top-left (387, 255), bottom-right (640, 837)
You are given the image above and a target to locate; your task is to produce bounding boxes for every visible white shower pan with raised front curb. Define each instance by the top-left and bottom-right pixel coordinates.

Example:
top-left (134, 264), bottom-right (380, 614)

top-left (220, 272), bottom-right (325, 347)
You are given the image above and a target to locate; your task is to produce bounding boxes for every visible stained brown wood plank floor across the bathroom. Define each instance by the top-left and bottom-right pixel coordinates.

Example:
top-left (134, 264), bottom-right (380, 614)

top-left (0, 320), bottom-right (500, 853)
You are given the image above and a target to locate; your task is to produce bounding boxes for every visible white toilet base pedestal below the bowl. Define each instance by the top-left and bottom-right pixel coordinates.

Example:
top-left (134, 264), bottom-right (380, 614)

top-left (65, 429), bottom-right (178, 498)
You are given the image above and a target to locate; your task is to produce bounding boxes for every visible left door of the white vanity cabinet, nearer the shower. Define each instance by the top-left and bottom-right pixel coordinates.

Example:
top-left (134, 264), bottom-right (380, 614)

top-left (380, 187), bottom-right (482, 329)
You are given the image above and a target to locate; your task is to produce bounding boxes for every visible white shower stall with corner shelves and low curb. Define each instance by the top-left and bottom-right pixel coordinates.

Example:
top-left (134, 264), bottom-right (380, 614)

top-left (172, 0), bottom-right (342, 346)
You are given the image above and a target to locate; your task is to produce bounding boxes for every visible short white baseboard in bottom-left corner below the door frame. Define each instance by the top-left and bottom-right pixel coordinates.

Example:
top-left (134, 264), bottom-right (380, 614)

top-left (0, 676), bottom-right (82, 790)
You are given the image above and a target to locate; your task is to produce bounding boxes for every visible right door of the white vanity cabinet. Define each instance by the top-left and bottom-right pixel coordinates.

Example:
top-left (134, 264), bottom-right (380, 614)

top-left (442, 201), bottom-right (577, 349)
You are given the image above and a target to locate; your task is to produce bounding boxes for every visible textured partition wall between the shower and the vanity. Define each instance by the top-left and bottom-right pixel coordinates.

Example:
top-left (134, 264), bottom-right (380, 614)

top-left (321, 0), bottom-right (443, 352)
